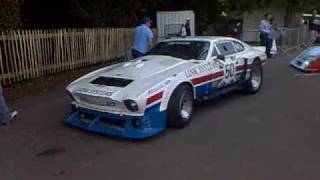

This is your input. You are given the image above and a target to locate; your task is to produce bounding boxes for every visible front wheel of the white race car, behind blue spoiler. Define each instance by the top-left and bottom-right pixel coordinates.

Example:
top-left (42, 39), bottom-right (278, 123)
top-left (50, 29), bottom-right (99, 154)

top-left (168, 84), bottom-right (194, 129)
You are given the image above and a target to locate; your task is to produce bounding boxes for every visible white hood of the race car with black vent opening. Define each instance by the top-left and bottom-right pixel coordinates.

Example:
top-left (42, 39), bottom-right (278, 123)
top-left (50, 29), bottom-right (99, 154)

top-left (67, 56), bottom-right (195, 101)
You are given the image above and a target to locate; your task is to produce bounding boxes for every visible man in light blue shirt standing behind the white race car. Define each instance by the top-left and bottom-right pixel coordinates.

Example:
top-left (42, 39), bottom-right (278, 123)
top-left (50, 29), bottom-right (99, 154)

top-left (132, 17), bottom-right (153, 58)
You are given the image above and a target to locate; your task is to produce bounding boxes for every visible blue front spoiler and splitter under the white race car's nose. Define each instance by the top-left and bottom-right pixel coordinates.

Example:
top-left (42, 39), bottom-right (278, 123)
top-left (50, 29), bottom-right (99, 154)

top-left (66, 103), bottom-right (167, 139)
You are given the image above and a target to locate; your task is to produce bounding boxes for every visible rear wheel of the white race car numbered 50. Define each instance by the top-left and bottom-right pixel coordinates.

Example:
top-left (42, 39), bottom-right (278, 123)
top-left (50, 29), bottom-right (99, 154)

top-left (242, 60), bottom-right (263, 94)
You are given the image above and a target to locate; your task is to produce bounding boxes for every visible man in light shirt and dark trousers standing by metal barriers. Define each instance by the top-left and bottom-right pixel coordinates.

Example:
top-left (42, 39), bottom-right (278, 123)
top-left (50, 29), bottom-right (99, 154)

top-left (259, 13), bottom-right (272, 58)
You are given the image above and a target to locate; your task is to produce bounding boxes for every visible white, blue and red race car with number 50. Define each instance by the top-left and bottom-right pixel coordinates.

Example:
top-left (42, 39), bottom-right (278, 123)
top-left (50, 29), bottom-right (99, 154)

top-left (66, 37), bottom-right (266, 138)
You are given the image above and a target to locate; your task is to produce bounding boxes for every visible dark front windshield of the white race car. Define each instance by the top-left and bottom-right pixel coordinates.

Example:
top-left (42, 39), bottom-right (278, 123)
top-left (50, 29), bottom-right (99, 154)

top-left (148, 41), bottom-right (210, 60)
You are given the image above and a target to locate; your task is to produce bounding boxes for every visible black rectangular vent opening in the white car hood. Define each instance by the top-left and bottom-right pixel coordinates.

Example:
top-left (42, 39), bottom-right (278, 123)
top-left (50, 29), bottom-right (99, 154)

top-left (90, 76), bottom-right (133, 87)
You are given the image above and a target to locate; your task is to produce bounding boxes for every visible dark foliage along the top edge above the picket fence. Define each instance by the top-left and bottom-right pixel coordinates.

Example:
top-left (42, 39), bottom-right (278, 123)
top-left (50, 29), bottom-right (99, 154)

top-left (0, 0), bottom-right (320, 29)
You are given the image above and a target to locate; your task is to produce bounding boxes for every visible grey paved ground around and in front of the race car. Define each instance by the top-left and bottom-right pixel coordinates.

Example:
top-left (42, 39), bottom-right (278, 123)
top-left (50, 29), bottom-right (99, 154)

top-left (0, 53), bottom-right (320, 180)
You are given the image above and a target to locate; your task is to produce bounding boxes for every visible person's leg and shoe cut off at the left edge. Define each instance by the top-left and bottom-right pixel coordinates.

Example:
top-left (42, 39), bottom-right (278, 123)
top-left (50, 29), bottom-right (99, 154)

top-left (0, 85), bottom-right (18, 126)
